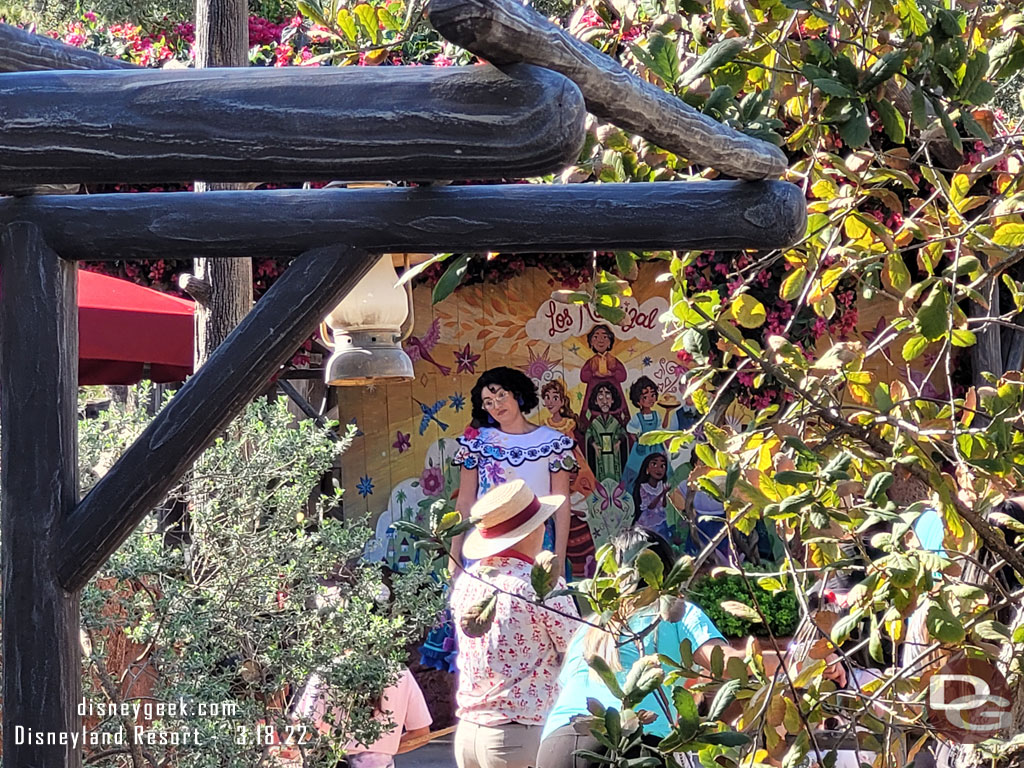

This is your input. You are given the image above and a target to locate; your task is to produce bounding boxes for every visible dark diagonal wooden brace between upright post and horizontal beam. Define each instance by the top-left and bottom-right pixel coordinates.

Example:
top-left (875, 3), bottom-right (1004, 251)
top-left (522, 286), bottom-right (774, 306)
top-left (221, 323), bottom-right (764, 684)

top-left (58, 246), bottom-right (374, 590)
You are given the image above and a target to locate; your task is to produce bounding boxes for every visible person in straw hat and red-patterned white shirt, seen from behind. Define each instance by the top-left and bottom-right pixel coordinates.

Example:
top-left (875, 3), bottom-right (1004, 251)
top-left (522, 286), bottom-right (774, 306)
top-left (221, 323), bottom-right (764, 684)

top-left (452, 479), bottom-right (579, 768)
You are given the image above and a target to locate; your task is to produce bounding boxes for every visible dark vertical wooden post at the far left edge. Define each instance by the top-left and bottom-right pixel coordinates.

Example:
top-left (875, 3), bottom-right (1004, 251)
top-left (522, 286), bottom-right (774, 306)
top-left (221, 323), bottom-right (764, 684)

top-left (0, 223), bottom-right (81, 768)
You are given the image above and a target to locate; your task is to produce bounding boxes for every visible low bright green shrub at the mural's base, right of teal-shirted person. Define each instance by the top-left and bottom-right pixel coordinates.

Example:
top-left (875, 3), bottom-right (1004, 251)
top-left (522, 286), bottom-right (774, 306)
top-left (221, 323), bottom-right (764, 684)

top-left (687, 573), bottom-right (800, 637)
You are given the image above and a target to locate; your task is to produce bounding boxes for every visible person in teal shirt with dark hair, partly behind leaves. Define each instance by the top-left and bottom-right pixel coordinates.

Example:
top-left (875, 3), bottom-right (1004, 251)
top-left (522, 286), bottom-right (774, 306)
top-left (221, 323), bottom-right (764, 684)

top-left (537, 528), bottom-right (735, 768)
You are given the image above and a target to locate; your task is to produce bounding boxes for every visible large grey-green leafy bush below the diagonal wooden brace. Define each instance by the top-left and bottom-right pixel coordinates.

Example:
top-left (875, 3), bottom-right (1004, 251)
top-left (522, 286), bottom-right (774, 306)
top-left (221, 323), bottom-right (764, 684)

top-left (80, 391), bottom-right (442, 768)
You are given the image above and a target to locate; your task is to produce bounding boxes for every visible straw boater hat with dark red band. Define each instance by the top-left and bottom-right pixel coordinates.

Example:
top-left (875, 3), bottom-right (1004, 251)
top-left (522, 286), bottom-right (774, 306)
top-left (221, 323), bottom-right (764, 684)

top-left (462, 479), bottom-right (565, 560)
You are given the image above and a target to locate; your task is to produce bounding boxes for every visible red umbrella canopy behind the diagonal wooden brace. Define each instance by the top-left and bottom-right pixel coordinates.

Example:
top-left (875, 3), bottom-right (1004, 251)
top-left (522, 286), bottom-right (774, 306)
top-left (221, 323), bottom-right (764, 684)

top-left (78, 269), bottom-right (194, 391)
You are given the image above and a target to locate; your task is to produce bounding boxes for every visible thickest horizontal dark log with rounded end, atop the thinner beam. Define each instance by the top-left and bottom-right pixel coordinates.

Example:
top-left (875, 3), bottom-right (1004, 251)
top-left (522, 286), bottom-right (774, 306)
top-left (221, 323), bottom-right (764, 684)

top-left (0, 65), bottom-right (586, 185)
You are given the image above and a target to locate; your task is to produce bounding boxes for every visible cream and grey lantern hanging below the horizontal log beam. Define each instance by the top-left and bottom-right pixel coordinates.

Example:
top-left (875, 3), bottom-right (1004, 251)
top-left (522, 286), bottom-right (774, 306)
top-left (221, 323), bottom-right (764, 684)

top-left (325, 254), bottom-right (414, 386)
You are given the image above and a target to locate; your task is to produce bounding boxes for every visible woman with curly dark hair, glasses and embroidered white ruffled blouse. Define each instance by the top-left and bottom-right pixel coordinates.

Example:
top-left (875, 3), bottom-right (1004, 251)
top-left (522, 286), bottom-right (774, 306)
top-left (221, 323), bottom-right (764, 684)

top-left (450, 367), bottom-right (577, 573)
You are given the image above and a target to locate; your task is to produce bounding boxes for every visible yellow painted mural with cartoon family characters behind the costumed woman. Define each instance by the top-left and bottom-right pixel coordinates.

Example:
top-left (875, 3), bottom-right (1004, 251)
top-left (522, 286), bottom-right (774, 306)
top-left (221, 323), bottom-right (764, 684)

top-left (340, 264), bottom-right (694, 575)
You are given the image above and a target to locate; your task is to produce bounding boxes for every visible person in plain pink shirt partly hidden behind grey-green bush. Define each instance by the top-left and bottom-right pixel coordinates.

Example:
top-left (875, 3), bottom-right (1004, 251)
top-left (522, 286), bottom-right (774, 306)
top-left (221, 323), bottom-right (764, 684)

top-left (295, 667), bottom-right (433, 768)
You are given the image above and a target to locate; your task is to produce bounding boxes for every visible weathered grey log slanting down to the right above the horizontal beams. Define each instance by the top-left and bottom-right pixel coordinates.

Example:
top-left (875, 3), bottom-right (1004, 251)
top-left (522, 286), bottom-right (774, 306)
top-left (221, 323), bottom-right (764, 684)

top-left (427, 0), bottom-right (788, 179)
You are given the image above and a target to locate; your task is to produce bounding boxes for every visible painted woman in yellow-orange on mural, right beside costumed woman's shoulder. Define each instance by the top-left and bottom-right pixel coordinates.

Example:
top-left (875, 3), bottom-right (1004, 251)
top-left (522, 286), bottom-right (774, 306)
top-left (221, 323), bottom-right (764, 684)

top-left (541, 379), bottom-right (597, 579)
